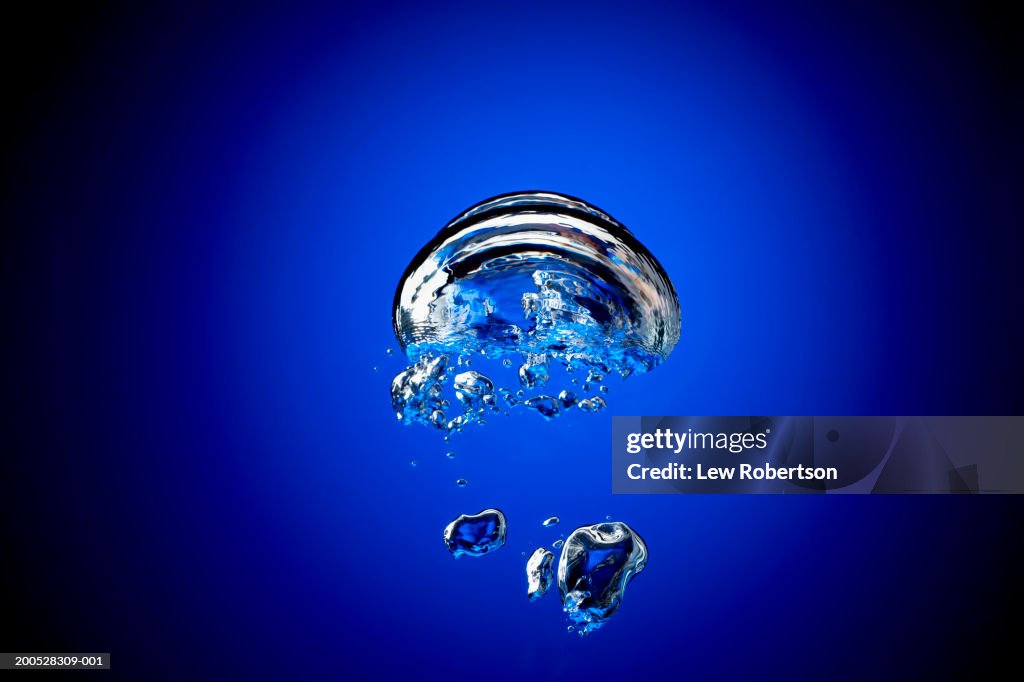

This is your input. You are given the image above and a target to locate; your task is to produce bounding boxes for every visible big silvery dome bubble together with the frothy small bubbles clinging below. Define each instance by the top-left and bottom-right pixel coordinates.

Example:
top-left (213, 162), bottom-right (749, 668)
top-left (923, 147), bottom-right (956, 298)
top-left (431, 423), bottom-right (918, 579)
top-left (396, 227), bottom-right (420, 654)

top-left (391, 188), bottom-right (680, 432)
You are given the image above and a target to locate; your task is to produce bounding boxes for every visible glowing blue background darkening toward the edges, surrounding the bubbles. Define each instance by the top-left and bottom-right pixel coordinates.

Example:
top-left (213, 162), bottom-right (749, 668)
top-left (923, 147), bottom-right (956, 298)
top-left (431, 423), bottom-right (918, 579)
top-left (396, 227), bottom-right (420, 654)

top-left (0, 2), bottom-right (1024, 680)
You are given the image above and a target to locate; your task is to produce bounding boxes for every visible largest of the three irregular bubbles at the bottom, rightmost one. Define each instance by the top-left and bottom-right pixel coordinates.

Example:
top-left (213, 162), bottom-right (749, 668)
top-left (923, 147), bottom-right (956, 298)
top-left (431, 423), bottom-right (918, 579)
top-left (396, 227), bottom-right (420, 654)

top-left (558, 521), bottom-right (647, 635)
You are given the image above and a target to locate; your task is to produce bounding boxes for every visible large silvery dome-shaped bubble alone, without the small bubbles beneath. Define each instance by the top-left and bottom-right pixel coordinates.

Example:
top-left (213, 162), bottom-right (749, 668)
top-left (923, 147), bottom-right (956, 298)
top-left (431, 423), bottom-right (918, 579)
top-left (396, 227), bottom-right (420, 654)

top-left (394, 191), bottom-right (680, 376)
